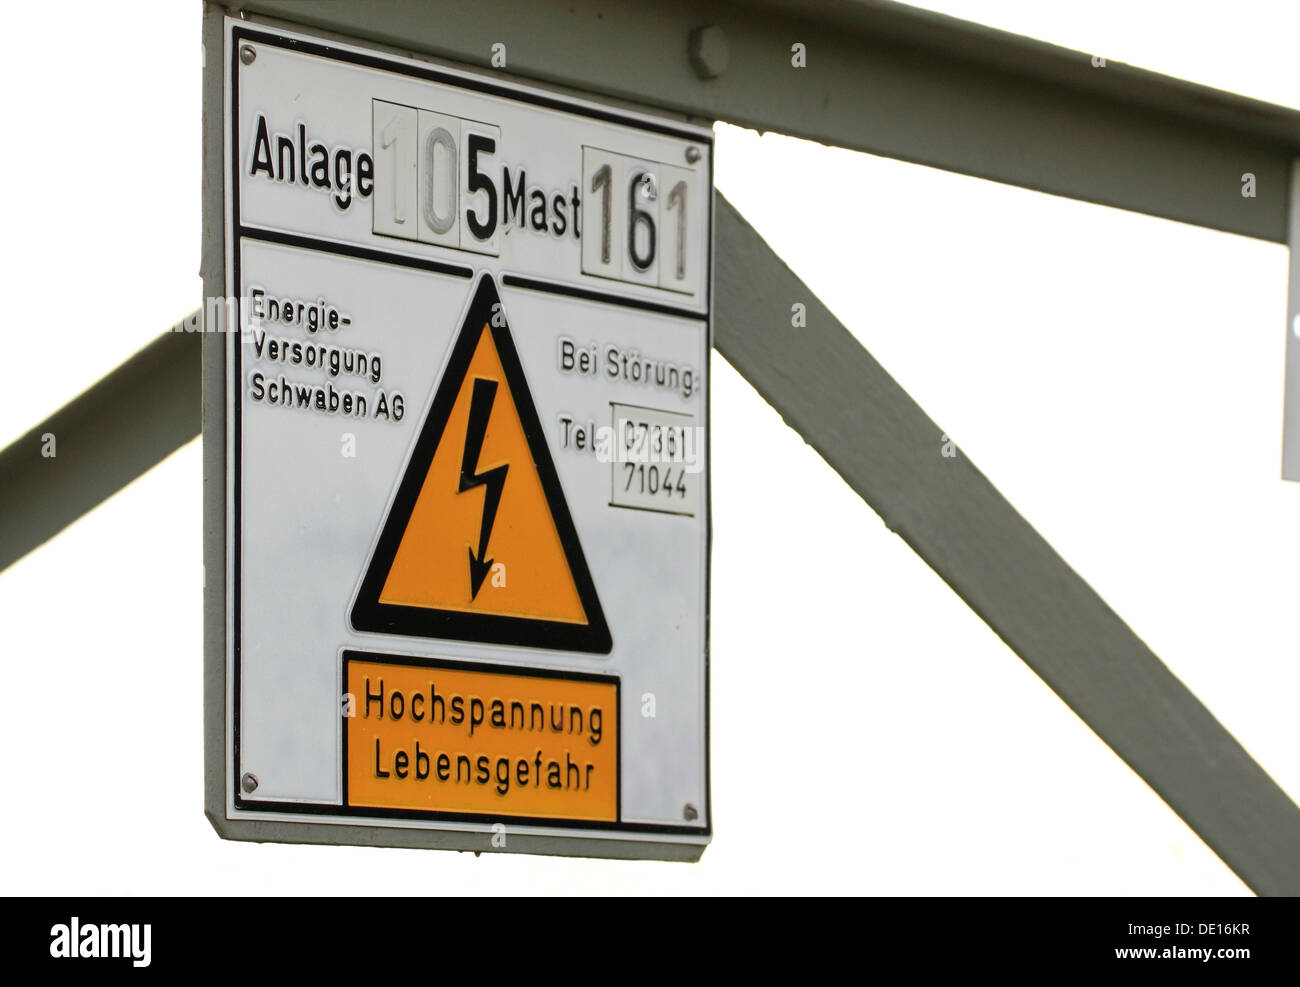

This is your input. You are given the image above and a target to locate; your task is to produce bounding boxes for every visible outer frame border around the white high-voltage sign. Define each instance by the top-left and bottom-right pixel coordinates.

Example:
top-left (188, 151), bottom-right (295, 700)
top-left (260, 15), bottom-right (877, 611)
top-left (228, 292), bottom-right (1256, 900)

top-left (202, 5), bottom-right (716, 861)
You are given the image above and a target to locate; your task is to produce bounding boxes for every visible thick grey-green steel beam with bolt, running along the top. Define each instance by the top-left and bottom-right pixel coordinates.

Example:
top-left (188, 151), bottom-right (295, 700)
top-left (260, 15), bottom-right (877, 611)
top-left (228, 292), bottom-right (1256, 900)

top-left (228, 0), bottom-right (1300, 243)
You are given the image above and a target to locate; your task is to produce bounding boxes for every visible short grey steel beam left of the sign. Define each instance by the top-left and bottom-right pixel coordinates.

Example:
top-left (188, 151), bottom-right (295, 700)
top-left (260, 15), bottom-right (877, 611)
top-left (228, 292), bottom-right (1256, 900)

top-left (0, 319), bottom-right (202, 570)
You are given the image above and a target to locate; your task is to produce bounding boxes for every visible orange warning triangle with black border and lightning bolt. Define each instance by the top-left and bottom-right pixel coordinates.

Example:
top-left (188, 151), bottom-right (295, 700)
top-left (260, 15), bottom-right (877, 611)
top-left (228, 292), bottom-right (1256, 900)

top-left (351, 274), bottom-right (611, 653)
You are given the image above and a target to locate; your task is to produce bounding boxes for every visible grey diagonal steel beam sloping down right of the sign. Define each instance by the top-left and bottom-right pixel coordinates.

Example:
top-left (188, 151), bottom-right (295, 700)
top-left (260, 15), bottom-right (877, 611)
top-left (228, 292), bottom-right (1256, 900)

top-left (714, 194), bottom-right (1300, 895)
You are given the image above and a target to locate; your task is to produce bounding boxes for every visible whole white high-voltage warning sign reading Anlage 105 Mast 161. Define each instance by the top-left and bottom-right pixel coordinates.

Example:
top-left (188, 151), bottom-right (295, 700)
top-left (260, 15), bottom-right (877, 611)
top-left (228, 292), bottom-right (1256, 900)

top-left (214, 14), bottom-right (714, 860)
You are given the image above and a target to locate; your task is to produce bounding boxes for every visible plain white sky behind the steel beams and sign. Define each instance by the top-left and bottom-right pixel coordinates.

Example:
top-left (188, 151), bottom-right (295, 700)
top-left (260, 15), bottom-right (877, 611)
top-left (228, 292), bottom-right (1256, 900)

top-left (0, 0), bottom-right (1300, 895)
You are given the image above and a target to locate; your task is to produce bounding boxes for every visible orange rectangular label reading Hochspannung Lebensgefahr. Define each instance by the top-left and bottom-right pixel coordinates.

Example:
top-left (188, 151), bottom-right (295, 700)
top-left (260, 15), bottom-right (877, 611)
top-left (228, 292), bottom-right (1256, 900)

top-left (343, 651), bottom-right (619, 822)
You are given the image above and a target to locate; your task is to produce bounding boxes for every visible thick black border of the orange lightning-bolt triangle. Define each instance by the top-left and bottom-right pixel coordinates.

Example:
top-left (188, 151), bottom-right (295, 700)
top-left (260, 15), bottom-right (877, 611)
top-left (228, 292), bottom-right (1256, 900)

top-left (350, 273), bottom-right (614, 654)
